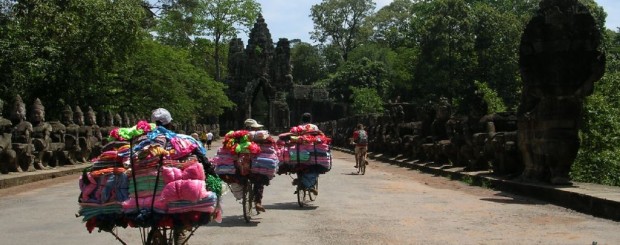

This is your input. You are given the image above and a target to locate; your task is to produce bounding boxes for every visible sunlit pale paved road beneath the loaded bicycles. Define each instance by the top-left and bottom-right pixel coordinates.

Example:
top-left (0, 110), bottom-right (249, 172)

top-left (0, 143), bottom-right (620, 245)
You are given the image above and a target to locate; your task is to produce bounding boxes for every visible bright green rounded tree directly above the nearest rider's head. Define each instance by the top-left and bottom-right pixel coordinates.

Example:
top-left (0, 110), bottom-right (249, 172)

top-left (111, 40), bottom-right (233, 121)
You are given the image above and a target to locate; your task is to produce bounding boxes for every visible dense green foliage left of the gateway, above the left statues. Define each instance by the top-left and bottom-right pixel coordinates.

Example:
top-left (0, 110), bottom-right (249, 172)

top-left (0, 0), bottom-right (240, 121)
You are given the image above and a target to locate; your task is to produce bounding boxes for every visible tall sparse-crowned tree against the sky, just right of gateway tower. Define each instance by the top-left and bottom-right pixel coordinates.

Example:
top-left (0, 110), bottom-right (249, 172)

top-left (310, 0), bottom-right (375, 61)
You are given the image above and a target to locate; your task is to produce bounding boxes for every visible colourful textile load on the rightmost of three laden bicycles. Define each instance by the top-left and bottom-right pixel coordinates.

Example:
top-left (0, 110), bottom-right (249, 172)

top-left (278, 127), bottom-right (332, 174)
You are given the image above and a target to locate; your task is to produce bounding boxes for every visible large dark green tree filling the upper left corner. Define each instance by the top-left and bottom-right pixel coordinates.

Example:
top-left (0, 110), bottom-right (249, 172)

top-left (0, 0), bottom-right (144, 115)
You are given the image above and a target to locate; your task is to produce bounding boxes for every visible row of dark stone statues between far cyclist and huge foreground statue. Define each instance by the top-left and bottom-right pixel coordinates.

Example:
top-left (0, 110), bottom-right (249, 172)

top-left (318, 101), bottom-right (523, 181)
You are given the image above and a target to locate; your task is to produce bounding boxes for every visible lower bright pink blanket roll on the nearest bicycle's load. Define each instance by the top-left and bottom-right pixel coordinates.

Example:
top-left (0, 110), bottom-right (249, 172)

top-left (161, 180), bottom-right (208, 203)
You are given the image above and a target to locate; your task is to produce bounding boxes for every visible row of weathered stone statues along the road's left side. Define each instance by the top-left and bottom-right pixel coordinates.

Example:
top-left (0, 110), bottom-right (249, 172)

top-left (0, 95), bottom-right (218, 174)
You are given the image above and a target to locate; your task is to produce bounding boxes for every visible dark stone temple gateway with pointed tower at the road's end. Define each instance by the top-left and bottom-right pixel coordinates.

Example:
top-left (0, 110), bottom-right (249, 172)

top-left (220, 15), bottom-right (293, 131)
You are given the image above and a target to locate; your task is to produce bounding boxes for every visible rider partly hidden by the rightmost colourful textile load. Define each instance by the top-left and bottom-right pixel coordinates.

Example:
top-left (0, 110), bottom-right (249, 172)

top-left (291, 112), bottom-right (323, 195)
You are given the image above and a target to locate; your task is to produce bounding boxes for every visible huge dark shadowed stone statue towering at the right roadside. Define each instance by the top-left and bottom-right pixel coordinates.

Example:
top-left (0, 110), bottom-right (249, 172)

top-left (517, 0), bottom-right (605, 184)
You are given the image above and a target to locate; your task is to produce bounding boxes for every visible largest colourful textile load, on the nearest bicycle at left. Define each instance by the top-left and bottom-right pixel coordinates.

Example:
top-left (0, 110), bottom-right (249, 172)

top-left (79, 121), bottom-right (222, 232)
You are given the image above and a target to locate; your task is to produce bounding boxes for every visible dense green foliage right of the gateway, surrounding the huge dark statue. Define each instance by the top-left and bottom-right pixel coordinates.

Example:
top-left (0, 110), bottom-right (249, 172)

top-left (302, 0), bottom-right (620, 185)
